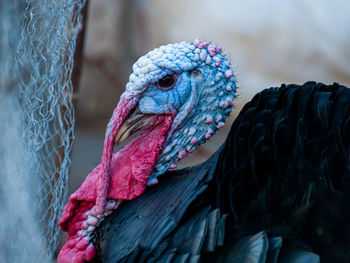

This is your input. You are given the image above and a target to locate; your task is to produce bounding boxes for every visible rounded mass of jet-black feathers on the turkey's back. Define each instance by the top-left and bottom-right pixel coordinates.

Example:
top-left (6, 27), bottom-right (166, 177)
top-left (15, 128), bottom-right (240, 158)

top-left (212, 82), bottom-right (350, 262)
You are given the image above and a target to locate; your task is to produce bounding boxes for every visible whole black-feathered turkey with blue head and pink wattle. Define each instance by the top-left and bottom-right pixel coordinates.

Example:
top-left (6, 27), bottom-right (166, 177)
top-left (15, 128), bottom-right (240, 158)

top-left (58, 39), bottom-right (350, 263)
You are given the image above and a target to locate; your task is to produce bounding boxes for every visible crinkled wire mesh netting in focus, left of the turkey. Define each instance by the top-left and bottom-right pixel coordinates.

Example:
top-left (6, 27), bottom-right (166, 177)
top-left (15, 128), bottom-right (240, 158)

top-left (5, 0), bottom-right (85, 257)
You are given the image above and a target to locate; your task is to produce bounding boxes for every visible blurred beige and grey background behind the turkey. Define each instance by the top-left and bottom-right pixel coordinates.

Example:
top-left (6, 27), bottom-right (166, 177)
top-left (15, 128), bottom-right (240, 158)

top-left (69, 0), bottom-right (350, 193)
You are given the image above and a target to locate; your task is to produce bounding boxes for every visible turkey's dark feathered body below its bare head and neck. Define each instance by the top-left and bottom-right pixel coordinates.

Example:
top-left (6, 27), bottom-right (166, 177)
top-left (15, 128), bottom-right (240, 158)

top-left (94, 82), bottom-right (350, 262)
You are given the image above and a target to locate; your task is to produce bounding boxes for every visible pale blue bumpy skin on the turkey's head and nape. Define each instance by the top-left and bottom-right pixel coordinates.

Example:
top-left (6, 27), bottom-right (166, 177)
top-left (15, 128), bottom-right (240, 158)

top-left (124, 40), bottom-right (236, 181)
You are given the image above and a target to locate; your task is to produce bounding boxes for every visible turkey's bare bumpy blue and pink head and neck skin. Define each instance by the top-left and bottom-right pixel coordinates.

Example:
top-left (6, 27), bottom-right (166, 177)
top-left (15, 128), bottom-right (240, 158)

top-left (58, 39), bottom-right (236, 263)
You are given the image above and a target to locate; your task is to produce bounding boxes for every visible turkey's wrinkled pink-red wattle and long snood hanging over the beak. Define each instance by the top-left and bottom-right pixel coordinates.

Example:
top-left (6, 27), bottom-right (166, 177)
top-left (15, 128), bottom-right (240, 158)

top-left (57, 96), bottom-right (178, 263)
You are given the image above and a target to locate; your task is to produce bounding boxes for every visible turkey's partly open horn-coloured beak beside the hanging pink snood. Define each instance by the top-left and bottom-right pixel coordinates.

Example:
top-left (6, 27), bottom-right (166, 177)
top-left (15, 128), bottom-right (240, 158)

top-left (114, 109), bottom-right (154, 145)
